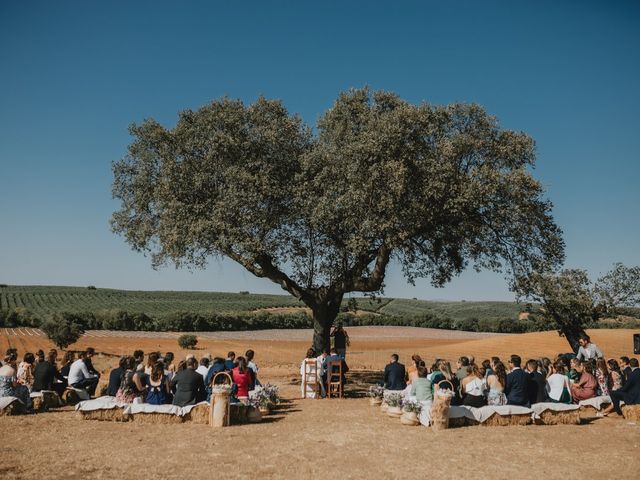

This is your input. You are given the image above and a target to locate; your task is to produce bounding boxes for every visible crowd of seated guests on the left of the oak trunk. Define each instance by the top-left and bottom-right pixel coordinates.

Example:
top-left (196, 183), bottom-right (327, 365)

top-left (0, 348), bottom-right (260, 410)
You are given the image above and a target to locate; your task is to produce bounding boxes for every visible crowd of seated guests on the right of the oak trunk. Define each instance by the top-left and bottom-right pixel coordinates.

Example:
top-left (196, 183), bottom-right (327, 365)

top-left (381, 337), bottom-right (640, 415)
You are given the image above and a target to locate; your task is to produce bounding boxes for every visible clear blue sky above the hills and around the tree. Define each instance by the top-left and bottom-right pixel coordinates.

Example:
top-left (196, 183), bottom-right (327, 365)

top-left (0, 1), bottom-right (640, 300)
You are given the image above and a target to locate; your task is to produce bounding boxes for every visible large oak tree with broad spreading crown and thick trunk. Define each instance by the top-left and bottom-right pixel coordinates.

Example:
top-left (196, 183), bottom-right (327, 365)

top-left (112, 88), bottom-right (563, 350)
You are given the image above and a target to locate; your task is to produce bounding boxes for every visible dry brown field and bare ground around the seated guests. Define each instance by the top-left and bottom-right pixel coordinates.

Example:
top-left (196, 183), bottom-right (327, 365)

top-left (0, 327), bottom-right (640, 479)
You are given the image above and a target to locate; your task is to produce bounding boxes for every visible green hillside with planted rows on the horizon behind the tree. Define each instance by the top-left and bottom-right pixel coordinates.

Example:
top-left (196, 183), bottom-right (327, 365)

top-left (0, 286), bottom-right (523, 320)
